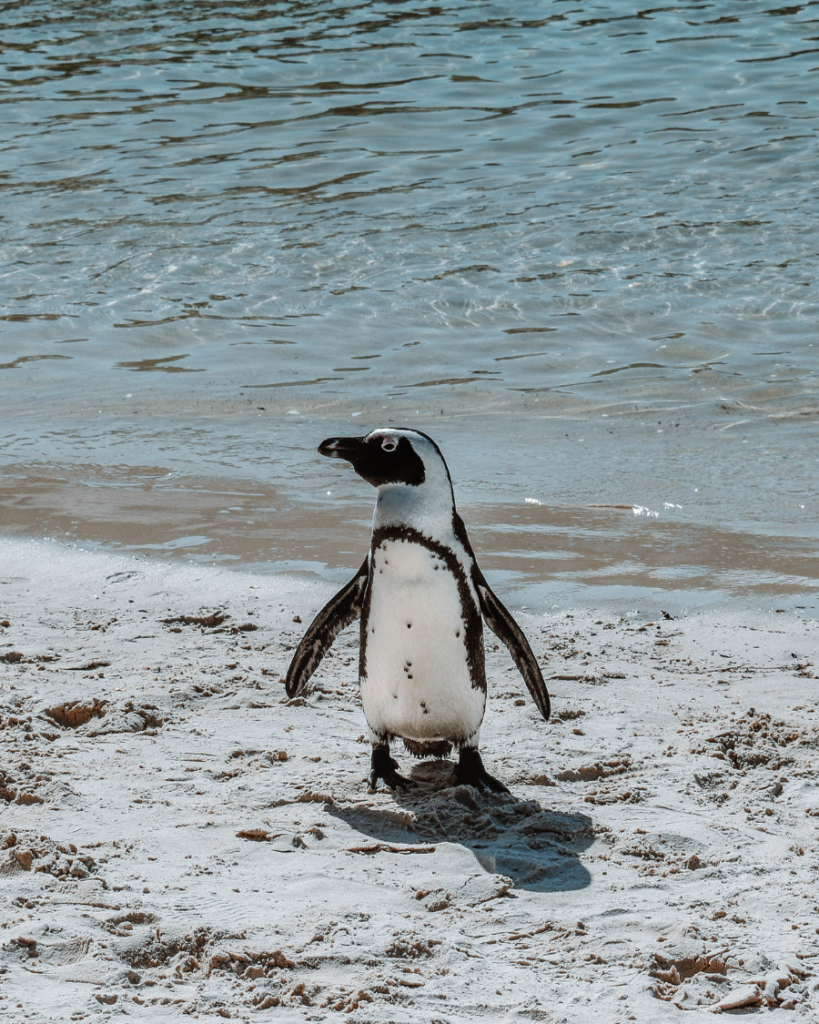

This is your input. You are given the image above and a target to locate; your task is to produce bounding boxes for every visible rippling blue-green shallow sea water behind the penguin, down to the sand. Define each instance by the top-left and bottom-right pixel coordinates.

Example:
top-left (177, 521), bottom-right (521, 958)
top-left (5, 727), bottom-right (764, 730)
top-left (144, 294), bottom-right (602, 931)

top-left (0, 0), bottom-right (819, 613)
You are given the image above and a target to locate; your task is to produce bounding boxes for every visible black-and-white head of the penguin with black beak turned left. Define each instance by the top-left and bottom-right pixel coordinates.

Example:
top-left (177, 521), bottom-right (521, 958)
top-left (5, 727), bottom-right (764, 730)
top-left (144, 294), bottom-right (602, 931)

top-left (318, 427), bottom-right (451, 487)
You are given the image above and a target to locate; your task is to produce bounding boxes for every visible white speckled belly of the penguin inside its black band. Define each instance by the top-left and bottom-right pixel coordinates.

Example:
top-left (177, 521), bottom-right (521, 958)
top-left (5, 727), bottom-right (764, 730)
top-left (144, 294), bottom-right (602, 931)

top-left (360, 540), bottom-right (486, 741)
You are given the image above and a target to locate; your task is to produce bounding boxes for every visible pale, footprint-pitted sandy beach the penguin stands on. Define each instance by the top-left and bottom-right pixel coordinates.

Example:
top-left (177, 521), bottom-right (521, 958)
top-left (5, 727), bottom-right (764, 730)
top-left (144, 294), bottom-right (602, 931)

top-left (0, 540), bottom-right (819, 1022)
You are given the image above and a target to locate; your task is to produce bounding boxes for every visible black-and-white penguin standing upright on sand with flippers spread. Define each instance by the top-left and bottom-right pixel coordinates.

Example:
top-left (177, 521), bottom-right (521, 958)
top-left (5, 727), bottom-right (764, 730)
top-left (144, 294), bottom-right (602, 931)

top-left (285, 427), bottom-right (551, 793)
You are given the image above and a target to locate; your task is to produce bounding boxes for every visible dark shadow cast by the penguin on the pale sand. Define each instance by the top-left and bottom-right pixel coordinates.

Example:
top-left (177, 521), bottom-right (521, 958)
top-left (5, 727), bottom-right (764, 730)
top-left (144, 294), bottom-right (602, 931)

top-left (327, 760), bottom-right (595, 892)
